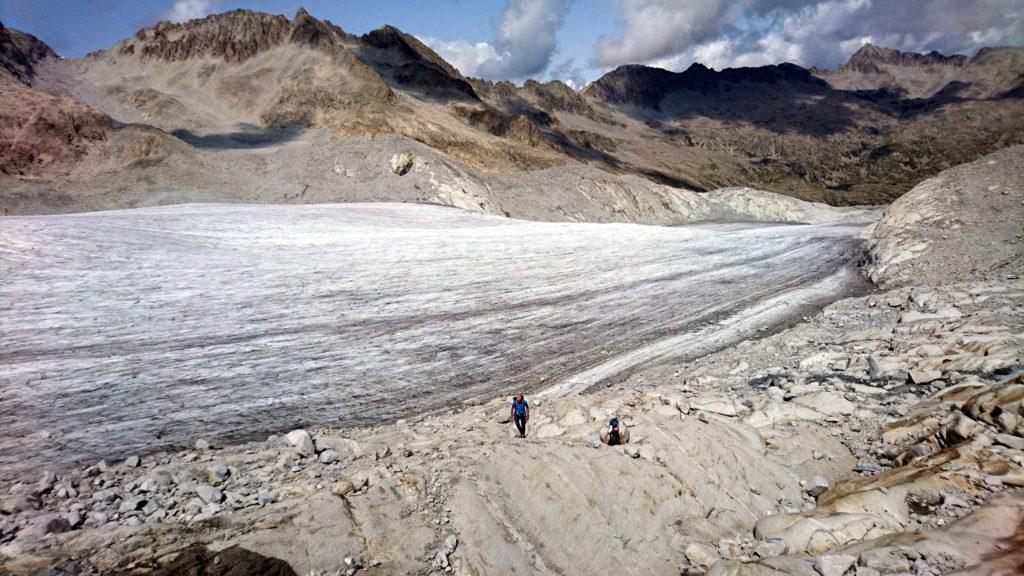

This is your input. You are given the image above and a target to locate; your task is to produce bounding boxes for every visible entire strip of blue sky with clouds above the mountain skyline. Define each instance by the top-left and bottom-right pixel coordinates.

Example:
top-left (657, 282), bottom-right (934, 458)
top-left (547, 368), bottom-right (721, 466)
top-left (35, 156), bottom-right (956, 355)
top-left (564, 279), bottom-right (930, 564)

top-left (0, 0), bottom-right (1024, 87)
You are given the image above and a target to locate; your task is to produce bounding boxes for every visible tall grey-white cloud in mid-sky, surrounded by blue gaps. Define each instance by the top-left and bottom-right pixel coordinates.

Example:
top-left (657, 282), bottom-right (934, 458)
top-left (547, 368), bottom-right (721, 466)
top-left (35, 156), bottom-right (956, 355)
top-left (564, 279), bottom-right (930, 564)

top-left (423, 0), bottom-right (568, 80)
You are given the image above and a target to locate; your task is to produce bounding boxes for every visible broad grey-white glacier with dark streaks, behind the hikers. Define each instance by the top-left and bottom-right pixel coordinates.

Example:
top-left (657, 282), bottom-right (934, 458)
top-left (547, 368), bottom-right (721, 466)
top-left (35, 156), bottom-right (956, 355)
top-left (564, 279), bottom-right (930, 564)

top-left (0, 204), bottom-right (860, 477)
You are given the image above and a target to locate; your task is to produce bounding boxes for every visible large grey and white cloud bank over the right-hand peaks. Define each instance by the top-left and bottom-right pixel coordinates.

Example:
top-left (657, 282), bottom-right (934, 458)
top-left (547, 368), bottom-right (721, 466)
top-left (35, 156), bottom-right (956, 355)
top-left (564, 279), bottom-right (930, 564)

top-left (592, 0), bottom-right (1024, 70)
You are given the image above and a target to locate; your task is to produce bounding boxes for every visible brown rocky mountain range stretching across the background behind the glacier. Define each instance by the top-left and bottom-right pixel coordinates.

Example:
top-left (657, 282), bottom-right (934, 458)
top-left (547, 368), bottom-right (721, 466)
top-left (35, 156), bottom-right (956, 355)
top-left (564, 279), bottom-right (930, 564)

top-left (0, 9), bottom-right (1024, 215)
